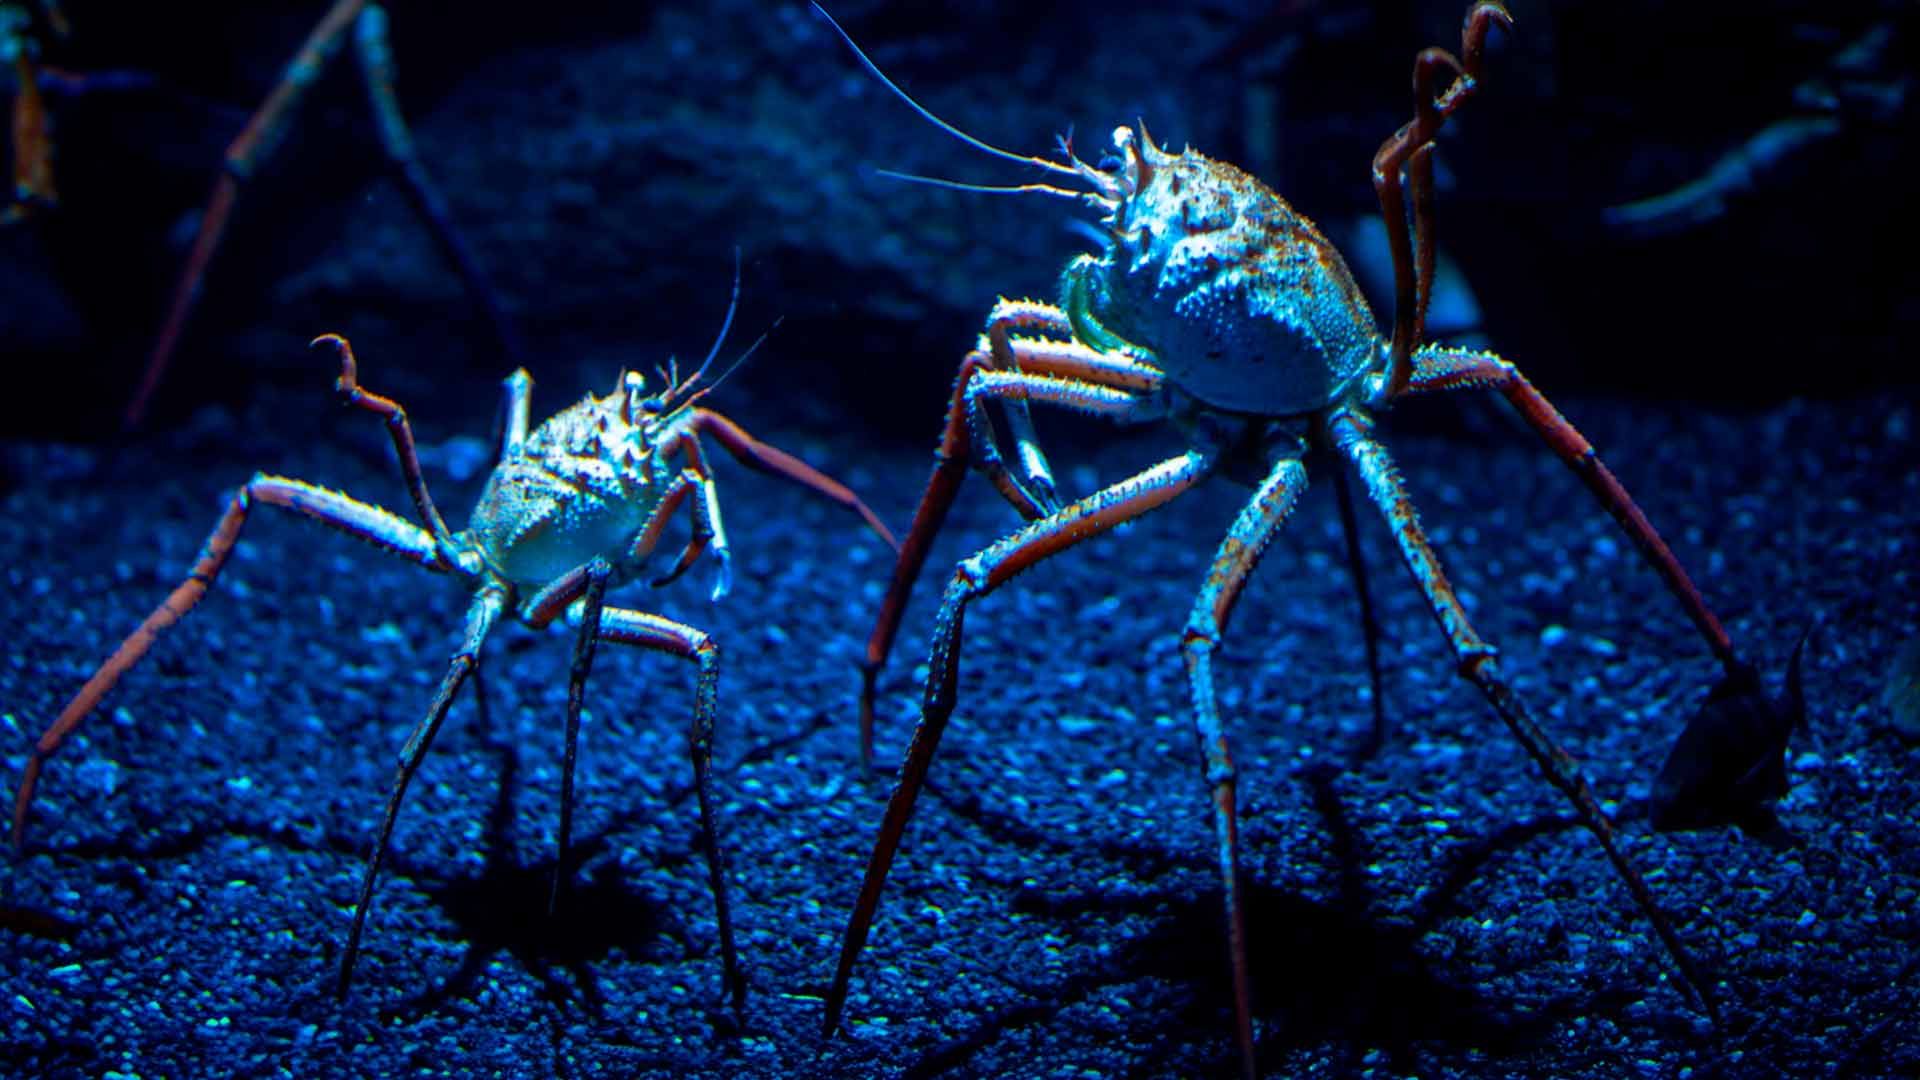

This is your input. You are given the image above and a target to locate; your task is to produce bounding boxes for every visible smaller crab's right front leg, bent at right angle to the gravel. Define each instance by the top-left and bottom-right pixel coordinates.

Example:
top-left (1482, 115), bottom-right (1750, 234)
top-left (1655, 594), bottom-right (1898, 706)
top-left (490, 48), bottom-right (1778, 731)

top-left (599, 607), bottom-right (747, 1009)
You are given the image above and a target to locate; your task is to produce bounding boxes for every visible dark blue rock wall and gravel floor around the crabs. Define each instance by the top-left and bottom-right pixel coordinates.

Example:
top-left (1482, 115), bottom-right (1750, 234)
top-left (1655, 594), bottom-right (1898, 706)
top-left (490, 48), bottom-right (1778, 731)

top-left (0, 0), bottom-right (1920, 1078)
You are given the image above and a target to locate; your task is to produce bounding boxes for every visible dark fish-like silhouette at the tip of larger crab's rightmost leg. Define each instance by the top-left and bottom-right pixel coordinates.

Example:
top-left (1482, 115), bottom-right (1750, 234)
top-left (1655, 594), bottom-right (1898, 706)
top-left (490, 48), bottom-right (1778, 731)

top-left (1651, 626), bottom-right (1812, 840)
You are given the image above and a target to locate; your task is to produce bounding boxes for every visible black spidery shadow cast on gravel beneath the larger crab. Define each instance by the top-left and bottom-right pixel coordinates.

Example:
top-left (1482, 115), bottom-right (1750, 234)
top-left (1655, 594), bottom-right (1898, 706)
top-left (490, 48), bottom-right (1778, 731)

top-left (887, 767), bottom-right (1640, 1078)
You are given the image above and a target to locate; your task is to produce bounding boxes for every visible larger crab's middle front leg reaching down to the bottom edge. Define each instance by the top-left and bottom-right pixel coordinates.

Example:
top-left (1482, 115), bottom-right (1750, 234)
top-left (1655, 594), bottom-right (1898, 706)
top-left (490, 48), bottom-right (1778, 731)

top-left (1181, 457), bottom-right (1308, 1080)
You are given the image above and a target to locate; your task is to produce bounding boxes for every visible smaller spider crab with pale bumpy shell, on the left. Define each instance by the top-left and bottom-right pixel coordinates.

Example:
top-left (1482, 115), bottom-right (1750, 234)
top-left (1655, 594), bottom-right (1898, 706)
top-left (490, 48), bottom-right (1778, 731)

top-left (13, 267), bottom-right (899, 1005)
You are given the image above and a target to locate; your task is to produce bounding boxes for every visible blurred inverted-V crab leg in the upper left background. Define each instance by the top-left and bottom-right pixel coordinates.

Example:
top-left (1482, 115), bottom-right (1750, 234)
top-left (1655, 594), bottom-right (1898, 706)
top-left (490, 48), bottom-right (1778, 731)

top-left (123, 0), bottom-right (520, 429)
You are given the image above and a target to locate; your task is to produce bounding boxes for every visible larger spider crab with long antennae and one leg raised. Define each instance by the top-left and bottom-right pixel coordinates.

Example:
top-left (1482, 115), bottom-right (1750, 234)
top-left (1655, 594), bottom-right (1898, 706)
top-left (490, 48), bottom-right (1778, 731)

top-left (814, 0), bottom-right (1757, 1076)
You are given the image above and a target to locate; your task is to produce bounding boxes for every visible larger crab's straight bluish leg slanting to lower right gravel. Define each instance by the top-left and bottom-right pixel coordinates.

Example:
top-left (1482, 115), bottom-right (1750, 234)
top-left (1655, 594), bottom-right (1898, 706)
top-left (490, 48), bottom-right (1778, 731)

top-left (1332, 413), bottom-right (1718, 1022)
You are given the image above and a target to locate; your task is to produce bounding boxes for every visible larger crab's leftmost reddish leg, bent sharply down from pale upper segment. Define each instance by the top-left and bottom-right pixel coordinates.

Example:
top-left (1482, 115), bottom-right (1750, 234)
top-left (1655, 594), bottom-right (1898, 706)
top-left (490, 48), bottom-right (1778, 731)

top-left (860, 343), bottom-right (1162, 771)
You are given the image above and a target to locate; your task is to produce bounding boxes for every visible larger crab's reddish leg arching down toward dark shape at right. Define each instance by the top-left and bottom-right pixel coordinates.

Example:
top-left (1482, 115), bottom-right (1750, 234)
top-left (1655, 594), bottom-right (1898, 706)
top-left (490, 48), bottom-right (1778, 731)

top-left (1407, 346), bottom-right (1745, 675)
